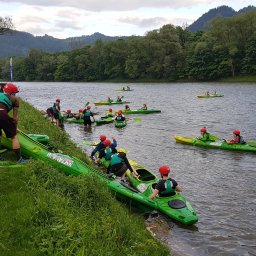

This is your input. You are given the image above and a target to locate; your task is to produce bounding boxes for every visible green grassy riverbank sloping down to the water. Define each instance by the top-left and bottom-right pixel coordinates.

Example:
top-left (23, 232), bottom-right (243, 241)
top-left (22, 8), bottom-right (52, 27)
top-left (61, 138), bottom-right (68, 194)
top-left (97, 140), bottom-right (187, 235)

top-left (0, 100), bottom-right (170, 256)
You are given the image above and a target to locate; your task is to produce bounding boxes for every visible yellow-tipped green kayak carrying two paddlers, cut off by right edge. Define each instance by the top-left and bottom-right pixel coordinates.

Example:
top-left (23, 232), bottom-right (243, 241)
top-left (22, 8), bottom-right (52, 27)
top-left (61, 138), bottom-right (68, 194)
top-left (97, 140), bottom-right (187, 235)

top-left (174, 135), bottom-right (256, 152)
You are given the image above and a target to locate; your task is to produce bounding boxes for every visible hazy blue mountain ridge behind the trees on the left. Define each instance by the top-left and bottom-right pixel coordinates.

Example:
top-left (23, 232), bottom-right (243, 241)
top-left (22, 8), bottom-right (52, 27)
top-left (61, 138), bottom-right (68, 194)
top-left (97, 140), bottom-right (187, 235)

top-left (0, 31), bottom-right (128, 57)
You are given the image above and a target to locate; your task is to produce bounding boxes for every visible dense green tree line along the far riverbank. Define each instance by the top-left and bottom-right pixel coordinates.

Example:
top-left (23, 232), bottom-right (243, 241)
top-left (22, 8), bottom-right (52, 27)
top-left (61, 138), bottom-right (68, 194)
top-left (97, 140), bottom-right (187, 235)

top-left (0, 11), bottom-right (256, 81)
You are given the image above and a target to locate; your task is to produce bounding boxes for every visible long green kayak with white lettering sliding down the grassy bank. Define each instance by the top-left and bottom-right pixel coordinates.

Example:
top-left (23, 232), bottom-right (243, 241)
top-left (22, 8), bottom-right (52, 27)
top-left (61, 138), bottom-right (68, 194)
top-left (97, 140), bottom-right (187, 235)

top-left (2, 131), bottom-right (189, 223)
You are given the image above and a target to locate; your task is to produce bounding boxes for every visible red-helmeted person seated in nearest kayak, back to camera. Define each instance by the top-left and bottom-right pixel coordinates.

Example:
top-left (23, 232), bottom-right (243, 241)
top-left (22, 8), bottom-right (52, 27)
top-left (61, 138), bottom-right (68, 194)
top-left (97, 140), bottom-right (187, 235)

top-left (149, 165), bottom-right (182, 199)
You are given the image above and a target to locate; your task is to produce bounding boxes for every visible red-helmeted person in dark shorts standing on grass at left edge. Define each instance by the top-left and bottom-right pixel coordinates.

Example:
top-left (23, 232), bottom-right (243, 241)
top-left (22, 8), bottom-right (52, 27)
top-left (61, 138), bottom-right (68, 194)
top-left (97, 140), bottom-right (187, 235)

top-left (0, 83), bottom-right (26, 164)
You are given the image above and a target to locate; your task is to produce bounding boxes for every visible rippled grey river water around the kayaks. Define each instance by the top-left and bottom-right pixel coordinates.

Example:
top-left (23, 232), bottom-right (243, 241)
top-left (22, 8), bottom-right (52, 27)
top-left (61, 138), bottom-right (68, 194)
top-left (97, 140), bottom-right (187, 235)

top-left (18, 83), bottom-right (256, 256)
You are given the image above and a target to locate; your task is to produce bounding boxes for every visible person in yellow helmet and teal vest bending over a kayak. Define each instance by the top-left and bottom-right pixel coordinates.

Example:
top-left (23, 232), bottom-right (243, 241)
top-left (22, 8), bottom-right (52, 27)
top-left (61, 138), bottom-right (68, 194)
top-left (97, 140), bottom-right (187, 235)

top-left (107, 149), bottom-right (139, 181)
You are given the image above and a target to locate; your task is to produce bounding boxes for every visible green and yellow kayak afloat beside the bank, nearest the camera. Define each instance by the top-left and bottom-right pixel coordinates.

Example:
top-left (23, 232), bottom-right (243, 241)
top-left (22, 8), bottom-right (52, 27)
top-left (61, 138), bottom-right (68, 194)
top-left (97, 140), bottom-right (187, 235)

top-left (127, 160), bottom-right (198, 225)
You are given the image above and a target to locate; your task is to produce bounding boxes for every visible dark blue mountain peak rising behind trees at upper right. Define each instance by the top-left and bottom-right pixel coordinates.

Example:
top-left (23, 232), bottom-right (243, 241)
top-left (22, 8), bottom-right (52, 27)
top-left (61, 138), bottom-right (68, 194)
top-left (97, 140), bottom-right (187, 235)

top-left (188, 5), bottom-right (256, 31)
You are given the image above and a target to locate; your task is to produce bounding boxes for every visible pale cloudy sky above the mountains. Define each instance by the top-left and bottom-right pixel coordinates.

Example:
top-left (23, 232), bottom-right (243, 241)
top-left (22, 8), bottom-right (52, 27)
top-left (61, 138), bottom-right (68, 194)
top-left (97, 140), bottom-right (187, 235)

top-left (0, 0), bottom-right (256, 39)
